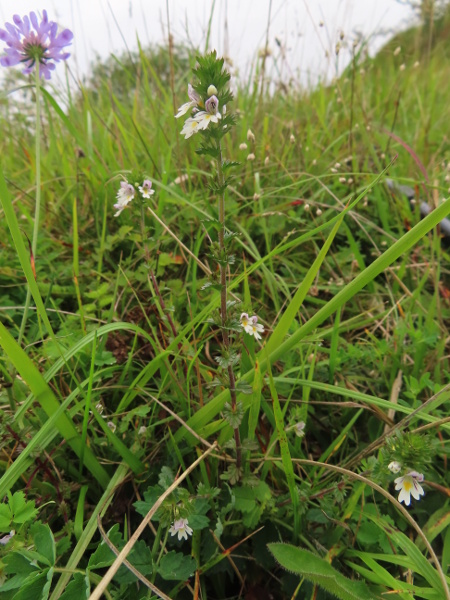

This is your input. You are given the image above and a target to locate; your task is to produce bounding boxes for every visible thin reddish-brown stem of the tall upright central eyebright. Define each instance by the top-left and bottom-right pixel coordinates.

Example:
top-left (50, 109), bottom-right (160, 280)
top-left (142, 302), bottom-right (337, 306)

top-left (217, 142), bottom-right (242, 469)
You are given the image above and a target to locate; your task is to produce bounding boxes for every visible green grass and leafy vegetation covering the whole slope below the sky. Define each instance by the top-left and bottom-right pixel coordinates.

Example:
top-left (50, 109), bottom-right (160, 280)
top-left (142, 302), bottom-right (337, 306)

top-left (0, 5), bottom-right (450, 600)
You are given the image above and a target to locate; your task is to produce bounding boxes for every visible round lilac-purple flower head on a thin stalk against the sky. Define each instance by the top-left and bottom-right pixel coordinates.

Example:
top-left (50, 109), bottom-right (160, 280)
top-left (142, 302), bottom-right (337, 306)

top-left (0, 10), bottom-right (73, 79)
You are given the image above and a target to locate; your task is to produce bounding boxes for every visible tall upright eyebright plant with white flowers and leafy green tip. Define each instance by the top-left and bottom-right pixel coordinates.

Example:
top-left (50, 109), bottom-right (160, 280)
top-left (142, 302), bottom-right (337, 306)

top-left (175, 52), bottom-right (264, 483)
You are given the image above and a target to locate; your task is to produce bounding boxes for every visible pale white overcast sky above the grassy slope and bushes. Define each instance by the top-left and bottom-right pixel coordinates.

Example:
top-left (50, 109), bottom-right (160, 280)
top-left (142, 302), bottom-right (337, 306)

top-left (0, 0), bottom-right (413, 83)
